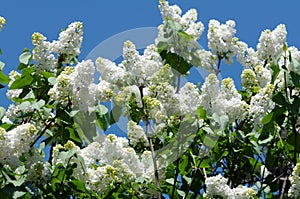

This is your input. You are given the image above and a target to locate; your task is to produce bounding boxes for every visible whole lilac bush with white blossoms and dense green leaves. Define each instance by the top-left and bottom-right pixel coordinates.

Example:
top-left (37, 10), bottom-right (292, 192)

top-left (0, 0), bottom-right (300, 199)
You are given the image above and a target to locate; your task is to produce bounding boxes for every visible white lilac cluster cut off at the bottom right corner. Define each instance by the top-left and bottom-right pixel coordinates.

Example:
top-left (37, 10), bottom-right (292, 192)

top-left (288, 162), bottom-right (300, 198)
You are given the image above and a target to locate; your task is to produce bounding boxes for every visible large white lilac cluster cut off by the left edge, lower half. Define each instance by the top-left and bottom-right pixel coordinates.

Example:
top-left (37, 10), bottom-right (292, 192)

top-left (0, 123), bottom-right (36, 169)
